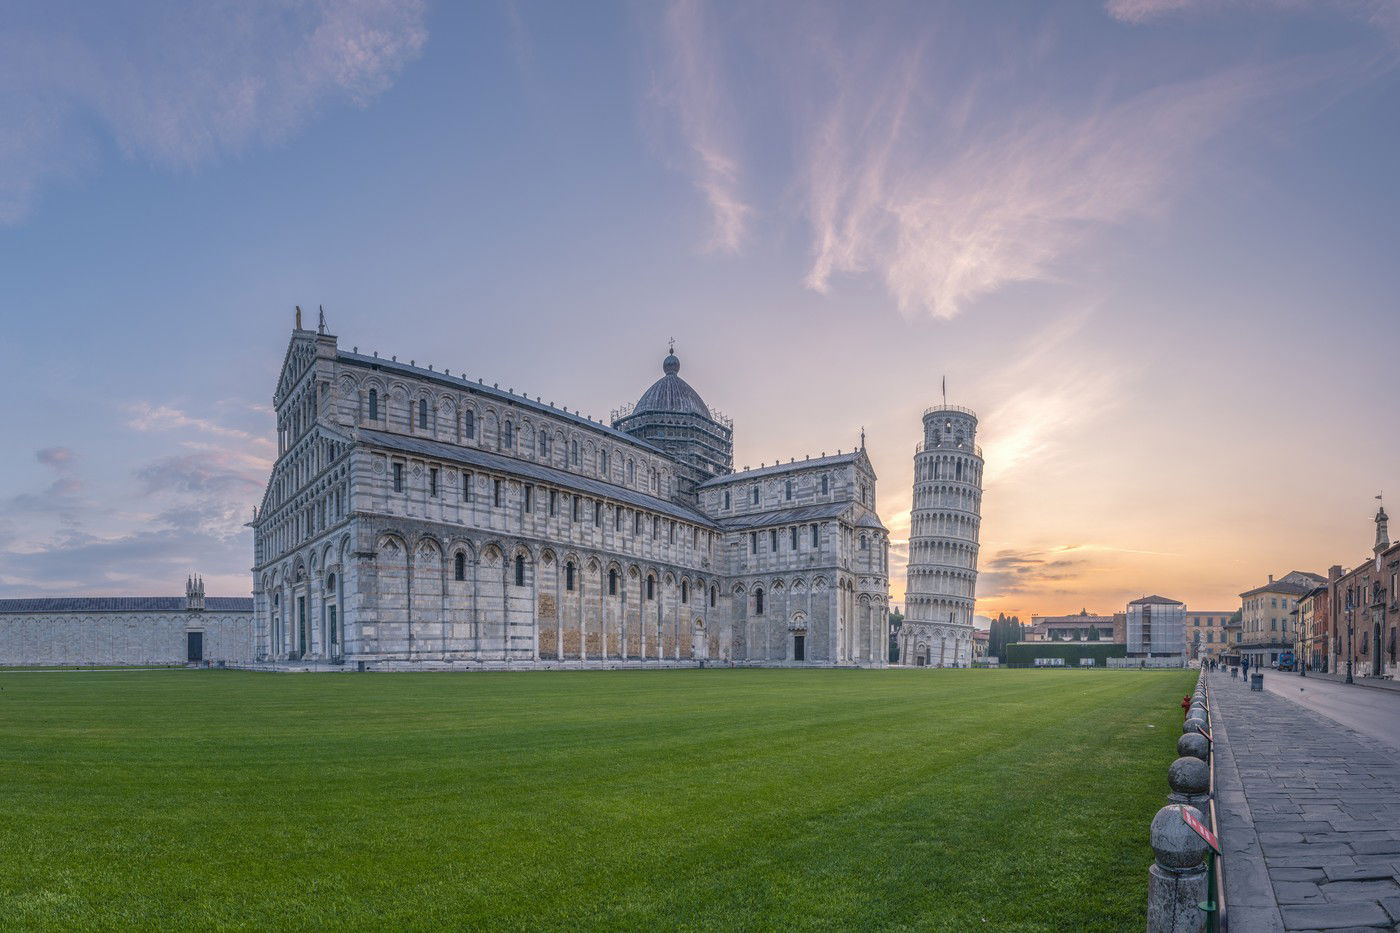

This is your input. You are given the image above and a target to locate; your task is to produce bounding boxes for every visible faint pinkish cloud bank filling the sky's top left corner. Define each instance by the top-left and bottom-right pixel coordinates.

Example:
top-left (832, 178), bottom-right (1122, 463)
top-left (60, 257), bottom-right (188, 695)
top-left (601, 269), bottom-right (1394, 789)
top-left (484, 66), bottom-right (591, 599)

top-left (0, 0), bottom-right (427, 224)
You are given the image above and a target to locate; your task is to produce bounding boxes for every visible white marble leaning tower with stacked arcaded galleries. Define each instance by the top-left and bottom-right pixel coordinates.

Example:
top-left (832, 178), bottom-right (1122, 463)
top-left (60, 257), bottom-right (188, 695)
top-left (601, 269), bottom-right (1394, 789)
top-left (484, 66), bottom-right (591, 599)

top-left (899, 403), bottom-right (983, 667)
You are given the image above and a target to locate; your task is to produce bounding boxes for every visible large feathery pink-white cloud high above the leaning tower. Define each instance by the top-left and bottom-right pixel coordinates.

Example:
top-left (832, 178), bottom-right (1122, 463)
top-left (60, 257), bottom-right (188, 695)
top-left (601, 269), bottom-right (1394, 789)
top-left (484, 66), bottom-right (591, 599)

top-left (805, 53), bottom-right (1274, 318)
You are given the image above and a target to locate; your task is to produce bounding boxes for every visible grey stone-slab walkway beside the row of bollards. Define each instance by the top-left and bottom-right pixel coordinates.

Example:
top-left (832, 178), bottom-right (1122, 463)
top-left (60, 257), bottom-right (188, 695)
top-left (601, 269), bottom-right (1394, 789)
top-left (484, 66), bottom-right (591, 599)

top-left (1208, 671), bottom-right (1400, 933)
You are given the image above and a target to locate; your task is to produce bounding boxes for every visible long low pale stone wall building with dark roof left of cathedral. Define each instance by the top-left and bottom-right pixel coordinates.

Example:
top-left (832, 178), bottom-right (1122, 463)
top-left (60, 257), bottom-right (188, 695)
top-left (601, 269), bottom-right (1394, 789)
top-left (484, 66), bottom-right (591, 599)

top-left (0, 577), bottom-right (253, 667)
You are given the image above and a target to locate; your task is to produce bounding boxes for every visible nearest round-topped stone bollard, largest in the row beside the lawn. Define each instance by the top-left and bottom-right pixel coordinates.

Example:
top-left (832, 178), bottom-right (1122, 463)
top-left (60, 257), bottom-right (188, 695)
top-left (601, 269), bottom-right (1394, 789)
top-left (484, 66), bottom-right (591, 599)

top-left (1147, 804), bottom-right (1208, 933)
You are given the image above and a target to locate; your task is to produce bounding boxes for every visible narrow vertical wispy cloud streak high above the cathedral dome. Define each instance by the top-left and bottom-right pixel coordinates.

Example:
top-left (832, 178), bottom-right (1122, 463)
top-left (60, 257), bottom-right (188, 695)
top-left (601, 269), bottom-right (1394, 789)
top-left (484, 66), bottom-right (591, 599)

top-left (651, 0), bottom-right (753, 254)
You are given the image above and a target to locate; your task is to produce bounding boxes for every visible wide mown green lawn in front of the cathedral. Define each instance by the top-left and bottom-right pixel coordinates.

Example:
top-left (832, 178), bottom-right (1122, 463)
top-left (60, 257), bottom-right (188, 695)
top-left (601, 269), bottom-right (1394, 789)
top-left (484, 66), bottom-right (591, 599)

top-left (0, 670), bottom-right (1194, 932)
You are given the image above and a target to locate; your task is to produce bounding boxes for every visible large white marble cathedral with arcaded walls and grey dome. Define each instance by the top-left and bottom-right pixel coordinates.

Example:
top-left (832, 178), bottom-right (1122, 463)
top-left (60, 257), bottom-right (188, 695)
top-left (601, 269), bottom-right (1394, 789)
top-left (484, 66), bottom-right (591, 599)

top-left (252, 311), bottom-right (884, 670)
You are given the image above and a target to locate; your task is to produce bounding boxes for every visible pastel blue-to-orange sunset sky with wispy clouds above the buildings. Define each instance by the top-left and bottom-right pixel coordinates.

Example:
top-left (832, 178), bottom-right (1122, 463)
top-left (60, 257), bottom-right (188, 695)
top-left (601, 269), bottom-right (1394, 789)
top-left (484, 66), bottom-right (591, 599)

top-left (0, 0), bottom-right (1400, 618)
